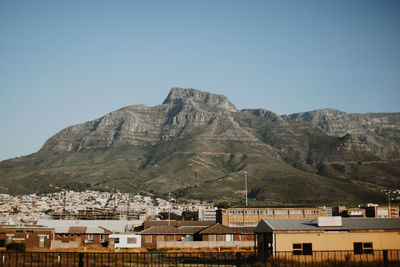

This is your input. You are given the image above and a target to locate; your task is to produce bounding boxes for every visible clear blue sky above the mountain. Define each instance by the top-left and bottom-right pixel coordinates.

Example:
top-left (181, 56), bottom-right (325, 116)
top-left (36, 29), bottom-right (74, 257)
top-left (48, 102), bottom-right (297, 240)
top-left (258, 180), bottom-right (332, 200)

top-left (0, 0), bottom-right (400, 160)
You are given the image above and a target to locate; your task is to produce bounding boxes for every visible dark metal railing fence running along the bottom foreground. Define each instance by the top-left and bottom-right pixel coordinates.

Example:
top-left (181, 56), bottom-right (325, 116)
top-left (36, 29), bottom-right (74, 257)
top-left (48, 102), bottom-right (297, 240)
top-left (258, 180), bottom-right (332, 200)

top-left (0, 250), bottom-right (400, 267)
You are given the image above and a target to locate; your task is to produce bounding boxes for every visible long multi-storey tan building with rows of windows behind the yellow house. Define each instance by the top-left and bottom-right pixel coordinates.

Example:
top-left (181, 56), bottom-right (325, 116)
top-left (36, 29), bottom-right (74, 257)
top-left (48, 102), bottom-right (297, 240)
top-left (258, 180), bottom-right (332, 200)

top-left (216, 207), bottom-right (328, 227)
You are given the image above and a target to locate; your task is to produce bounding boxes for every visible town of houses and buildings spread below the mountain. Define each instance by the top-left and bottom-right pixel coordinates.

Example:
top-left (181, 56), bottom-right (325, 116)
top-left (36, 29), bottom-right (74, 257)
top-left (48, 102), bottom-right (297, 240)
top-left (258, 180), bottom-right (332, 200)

top-left (0, 190), bottom-right (400, 262)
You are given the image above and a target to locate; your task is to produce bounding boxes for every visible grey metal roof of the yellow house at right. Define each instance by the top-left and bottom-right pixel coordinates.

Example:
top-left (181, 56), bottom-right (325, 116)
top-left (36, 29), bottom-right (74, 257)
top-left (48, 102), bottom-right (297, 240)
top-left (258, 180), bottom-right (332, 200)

top-left (255, 218), bottom-right (400, 233)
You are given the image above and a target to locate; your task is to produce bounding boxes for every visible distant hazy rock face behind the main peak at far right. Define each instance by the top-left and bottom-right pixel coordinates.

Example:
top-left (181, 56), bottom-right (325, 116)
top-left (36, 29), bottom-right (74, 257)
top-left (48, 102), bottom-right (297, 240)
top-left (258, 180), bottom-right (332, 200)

top-left (289, 109), bottom-right (400, 159)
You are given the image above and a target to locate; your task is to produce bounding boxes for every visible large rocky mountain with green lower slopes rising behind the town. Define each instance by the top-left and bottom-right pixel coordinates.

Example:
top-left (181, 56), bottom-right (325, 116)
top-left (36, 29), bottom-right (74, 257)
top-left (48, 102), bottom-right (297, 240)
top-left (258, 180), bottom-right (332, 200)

top-left (0, 88), bottom-right (400, 204)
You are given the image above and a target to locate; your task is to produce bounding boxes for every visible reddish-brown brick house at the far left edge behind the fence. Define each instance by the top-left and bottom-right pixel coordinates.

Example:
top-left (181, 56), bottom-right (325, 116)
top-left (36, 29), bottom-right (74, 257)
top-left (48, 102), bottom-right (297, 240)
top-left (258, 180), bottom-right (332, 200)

top-left (0, 225), bottom-right (54, 250)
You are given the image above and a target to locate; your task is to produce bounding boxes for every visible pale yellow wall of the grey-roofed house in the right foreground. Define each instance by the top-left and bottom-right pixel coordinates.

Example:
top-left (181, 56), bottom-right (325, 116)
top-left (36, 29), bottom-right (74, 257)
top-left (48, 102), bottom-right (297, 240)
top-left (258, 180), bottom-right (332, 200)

top-left (275, 231), bottom-right (400, 251)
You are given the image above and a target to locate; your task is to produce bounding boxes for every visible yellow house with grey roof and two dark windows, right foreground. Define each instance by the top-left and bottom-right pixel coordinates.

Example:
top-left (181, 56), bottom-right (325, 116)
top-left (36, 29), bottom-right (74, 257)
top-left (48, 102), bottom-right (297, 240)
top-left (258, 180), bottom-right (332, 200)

top-left (254, 217), bottom-right (400, 257)
